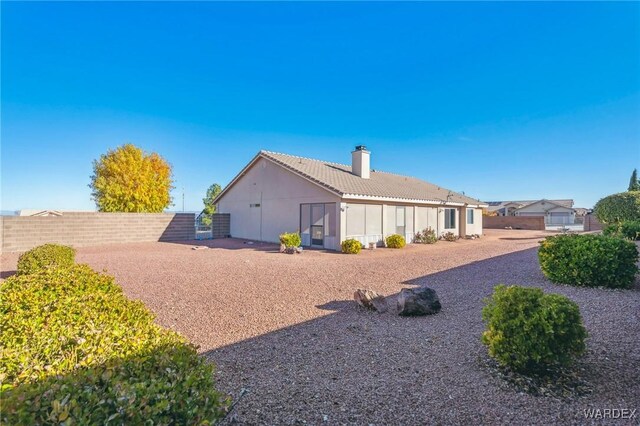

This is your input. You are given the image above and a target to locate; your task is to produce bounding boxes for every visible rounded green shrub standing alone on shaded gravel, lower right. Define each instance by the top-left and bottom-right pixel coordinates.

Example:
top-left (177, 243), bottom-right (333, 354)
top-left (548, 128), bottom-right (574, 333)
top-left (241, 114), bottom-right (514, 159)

top-left (482, 285), bottom-right (587, 372)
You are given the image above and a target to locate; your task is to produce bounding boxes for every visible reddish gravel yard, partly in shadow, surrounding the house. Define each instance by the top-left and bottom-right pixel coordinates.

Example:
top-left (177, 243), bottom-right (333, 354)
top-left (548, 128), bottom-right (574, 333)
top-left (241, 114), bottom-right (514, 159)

top-left (2, 230), bottom-right (640, 425)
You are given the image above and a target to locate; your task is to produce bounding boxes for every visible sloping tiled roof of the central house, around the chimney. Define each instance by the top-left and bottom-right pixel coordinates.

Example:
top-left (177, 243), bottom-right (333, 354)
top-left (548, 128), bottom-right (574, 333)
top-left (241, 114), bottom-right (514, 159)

top-left (259, 151), bottom-right (484, 205)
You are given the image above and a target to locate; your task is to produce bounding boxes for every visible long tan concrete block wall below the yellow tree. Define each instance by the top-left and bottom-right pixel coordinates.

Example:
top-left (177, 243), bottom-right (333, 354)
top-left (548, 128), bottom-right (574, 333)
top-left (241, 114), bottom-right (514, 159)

top-left (0, 212), bottom-right (195, 252)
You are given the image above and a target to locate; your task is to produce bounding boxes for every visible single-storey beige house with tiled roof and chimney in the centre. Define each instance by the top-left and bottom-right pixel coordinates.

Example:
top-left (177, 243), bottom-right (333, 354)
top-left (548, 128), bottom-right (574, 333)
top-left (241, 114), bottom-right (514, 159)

top-left (214, 146), bottom-right (487, 250)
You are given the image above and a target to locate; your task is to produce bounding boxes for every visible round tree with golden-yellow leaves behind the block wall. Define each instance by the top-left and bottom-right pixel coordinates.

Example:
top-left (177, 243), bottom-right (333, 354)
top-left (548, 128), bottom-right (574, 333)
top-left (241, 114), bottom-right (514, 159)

top-left (89, 144), bottom-right (173, 213)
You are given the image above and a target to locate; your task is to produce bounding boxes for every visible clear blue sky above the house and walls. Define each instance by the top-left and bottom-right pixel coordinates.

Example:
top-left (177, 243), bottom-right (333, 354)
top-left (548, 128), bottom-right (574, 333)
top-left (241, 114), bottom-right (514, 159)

top-left (1, 2), bottom-right (640, 210)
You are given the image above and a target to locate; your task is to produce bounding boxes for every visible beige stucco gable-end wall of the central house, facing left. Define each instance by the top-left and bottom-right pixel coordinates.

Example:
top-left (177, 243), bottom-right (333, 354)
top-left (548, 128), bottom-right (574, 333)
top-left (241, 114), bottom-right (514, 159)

top-left (218, 158), bottom-right (341, 249)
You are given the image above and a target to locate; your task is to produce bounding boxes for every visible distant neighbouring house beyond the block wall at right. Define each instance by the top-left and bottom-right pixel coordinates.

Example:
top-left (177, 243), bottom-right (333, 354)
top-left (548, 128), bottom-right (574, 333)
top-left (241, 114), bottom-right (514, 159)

top-left (487, 199), bottom-right (576, 225)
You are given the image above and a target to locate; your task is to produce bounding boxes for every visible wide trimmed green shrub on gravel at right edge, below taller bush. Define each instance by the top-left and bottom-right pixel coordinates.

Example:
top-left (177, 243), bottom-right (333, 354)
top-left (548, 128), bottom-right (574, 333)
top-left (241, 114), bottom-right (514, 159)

top-left (538, 234), bottom-right (638, 288)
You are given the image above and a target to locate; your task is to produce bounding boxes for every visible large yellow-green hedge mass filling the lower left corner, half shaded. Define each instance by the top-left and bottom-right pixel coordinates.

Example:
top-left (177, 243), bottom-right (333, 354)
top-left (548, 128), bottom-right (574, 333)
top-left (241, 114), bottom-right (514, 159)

top-left (0, 265), bottom-right (228, 424)
